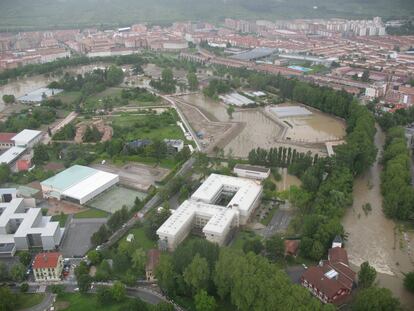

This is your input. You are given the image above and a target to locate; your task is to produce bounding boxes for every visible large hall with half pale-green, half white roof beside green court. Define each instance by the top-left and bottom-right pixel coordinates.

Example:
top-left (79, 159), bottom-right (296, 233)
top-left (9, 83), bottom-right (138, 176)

top-left (40, 165), bottom-right (119, 204)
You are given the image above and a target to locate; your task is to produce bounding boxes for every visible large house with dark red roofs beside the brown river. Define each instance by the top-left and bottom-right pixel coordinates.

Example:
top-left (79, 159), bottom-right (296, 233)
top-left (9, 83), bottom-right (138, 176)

top-left (301, 237), bottom-right (356, 305)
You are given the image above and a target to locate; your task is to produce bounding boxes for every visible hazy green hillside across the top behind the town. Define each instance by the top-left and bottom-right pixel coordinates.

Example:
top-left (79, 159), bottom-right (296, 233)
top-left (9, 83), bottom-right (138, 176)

top-left (0, 0), bottom-right (414, 30)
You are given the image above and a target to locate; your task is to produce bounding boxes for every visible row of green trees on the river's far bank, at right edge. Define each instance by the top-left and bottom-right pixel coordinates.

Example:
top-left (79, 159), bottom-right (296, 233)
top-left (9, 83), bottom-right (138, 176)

top-left (381, 127), bottom-right (414, 220)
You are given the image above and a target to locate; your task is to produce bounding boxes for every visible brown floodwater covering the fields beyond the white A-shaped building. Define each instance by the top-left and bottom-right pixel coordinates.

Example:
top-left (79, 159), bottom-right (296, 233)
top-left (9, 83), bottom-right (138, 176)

top-left (181, 94), bottom-right (345, 158)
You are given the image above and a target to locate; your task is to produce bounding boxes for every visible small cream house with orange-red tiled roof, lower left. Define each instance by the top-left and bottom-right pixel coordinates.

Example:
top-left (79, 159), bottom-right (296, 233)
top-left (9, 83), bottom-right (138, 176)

top-left (33, 252), bottom-right (63, 282)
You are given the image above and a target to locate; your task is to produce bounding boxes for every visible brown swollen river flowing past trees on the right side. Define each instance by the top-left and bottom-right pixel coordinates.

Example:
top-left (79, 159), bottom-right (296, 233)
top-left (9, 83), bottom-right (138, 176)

top-left (343, 128), bottom-right (414, 310)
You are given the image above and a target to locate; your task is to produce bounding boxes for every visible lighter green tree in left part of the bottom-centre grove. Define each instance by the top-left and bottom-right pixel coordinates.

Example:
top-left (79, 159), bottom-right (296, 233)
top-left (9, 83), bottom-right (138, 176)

top-left (183, 254), bottom-right (210, 292)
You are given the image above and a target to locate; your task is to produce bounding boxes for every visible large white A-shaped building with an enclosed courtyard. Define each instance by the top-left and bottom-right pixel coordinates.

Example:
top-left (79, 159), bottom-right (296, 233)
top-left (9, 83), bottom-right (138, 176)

top-left (157, 174), bottom-right (262, 250)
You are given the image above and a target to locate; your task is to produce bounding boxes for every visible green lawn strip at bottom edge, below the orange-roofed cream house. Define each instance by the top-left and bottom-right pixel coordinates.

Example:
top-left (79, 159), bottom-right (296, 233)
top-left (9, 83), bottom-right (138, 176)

top-left (56, 293), bottom-right (139, 311)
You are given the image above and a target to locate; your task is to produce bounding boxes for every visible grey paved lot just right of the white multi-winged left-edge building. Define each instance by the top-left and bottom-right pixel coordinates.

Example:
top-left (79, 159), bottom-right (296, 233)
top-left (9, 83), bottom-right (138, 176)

top-left (61, 218), bottom-right (107, 257)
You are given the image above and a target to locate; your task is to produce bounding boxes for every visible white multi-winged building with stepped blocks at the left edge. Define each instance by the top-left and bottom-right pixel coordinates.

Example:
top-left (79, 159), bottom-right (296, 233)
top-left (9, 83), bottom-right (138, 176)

top-left (0, 189), bottom-right (64, 257)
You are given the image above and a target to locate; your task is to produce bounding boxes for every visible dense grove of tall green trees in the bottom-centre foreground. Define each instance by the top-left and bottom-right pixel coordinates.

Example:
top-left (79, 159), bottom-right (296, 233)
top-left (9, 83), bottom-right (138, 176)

top-left (155, 239), bottom-right (335, 311)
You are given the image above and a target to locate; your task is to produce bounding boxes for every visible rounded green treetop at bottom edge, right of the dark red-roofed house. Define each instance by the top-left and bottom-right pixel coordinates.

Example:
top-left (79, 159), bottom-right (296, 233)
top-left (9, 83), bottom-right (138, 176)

top-left (352, 286), bottom-right (400, 311)
